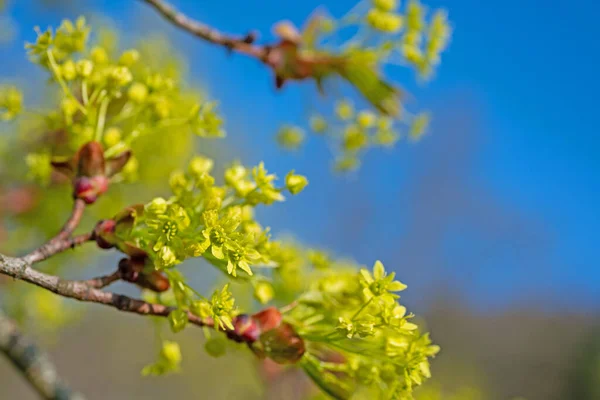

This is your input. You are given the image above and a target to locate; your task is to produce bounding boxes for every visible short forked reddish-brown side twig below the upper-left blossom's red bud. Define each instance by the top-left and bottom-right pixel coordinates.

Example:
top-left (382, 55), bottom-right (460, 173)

top-left (23, 199), bottom-right (88, 264)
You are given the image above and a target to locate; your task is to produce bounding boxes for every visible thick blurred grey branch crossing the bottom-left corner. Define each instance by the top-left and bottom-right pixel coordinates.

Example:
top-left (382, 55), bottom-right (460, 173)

top-left (0, 310), bottom-right (84, 400)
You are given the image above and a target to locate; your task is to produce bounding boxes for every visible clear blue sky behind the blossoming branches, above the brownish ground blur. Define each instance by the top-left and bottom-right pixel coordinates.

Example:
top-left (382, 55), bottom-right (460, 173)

top-left (0, 0), bottom-right (600, 311)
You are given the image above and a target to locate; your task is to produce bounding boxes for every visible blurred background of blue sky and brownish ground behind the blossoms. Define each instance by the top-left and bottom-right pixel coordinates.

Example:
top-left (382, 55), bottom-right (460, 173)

top-left (0, 0), bottom-right (600, 400)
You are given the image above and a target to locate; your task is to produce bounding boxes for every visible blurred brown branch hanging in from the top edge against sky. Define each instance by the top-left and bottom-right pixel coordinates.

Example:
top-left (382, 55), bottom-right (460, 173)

top-left (142, 0), bottom-right (270, 61)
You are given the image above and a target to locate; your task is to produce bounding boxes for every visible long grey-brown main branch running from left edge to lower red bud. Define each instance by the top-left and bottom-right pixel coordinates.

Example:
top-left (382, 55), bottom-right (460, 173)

top-left (0, 255), bottom-right (214, 327)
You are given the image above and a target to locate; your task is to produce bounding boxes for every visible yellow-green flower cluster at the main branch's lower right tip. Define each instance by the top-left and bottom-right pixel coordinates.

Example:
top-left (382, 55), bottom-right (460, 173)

top-left (284, 261), bottom-right (439, 399)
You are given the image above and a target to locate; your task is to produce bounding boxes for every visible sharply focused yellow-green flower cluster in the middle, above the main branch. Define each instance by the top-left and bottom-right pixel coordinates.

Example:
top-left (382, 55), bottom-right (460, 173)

top-left (123, 156), bottom-right (307, 278)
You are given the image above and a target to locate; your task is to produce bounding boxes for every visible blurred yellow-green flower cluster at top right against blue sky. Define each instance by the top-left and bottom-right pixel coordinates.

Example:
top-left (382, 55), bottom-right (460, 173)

top-left (277, 0), bottom-right (451, 171)
